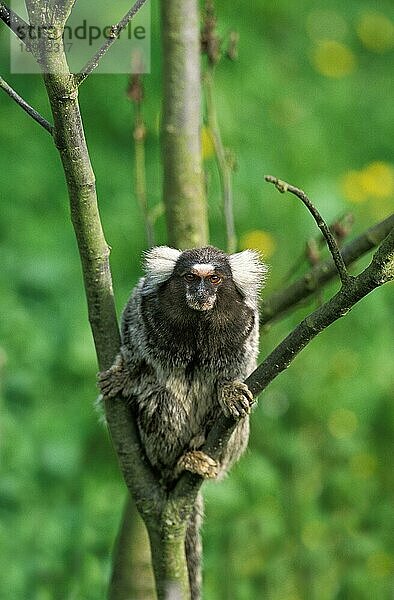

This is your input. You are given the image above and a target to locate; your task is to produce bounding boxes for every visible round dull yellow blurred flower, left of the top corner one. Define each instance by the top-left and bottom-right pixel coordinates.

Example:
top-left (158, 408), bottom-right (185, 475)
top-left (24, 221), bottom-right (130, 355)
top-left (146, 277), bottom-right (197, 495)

top-left (312, 40), bottom-right (356, 78)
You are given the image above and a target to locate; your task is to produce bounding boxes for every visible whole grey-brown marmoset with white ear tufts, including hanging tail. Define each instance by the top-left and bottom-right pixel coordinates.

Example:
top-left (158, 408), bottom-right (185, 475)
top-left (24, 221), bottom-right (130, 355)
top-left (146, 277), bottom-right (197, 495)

top-left (100, 246), bottom-right (266, 598)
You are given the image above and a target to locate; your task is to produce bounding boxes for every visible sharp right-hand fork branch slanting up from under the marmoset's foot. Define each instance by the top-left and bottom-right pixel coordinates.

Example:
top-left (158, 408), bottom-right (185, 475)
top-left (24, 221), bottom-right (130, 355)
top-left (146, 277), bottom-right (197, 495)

top-left (173, 229), bottom-right (394, 506)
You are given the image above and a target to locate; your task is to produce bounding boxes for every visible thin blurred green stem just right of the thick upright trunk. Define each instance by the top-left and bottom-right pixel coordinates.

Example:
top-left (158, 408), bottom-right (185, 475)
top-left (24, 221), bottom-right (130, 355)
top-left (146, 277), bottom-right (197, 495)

top-left (203, 64), bottom-right (237, 254)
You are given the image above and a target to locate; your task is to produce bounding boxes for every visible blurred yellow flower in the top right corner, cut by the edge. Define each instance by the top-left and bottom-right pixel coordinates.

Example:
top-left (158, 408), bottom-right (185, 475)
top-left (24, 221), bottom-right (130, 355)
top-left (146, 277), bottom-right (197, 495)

top-left (356, 12), bottom-right (394, 53)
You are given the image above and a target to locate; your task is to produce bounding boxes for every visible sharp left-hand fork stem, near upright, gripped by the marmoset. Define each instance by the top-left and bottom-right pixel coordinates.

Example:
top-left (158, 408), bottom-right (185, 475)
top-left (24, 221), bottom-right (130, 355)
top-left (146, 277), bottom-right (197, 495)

top-left (40, 30), bottom-right (161, 519)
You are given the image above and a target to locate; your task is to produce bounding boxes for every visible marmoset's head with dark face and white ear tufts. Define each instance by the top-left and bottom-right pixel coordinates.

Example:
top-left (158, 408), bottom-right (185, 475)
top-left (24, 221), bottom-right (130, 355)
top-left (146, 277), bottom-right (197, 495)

top-left (141, 246), bottom-right (266, 326)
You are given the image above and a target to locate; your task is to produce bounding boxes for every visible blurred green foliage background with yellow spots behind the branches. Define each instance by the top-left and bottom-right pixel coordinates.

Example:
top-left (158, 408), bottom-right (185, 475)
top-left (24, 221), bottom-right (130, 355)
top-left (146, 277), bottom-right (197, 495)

top-left (0, 0), bottom-right (394, 600)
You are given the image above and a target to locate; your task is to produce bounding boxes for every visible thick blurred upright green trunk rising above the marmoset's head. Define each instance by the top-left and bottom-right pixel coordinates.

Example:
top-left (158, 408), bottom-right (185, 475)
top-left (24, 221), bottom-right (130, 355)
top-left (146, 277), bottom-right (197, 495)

top-left (161, 0), bottom-right (208, 249)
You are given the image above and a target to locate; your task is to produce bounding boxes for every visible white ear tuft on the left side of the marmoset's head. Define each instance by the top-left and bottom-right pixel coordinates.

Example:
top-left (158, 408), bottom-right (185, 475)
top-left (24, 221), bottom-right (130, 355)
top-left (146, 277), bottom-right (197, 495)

top-left (143, 246), bottom-right (182, 294)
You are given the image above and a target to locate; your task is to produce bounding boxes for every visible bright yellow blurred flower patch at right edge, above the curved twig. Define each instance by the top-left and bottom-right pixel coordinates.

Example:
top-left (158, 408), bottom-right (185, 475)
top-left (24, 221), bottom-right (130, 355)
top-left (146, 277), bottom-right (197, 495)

top-left (341, 161), bottom-right (394, 203)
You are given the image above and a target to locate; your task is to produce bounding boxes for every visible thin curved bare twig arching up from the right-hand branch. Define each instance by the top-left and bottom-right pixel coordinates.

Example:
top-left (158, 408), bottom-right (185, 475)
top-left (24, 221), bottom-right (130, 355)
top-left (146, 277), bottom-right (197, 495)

top-left (264, 175), bottom-right (350, 285)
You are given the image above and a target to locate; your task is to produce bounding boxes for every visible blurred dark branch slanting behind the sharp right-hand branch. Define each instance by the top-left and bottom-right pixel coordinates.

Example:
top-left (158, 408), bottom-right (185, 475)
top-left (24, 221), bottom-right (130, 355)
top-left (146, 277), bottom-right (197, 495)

top-left (260, 214), bottom-right (394, 325)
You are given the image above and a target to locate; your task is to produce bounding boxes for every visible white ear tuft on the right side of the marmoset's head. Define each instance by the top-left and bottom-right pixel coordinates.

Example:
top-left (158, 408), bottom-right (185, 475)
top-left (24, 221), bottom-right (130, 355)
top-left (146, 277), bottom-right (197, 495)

top-left (229, 250), bottom-right (268, 308)
